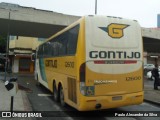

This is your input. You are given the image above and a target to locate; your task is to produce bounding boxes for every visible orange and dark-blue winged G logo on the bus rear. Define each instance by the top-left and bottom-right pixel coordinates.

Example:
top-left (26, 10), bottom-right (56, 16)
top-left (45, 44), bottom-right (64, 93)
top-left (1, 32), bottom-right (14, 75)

top-left (100, 23), bottom-right (129, 38)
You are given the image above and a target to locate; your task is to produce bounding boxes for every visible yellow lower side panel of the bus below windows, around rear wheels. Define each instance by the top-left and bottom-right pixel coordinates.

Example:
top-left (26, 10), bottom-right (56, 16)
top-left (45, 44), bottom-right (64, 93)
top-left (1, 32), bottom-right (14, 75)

top-left (45, 56), bottom-right (77, 104)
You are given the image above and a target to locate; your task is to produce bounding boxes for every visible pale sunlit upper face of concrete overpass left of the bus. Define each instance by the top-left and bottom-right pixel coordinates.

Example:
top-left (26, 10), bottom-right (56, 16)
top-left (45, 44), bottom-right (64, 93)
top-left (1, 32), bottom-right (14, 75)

top-left (0, 3), bottom-right (80, 26)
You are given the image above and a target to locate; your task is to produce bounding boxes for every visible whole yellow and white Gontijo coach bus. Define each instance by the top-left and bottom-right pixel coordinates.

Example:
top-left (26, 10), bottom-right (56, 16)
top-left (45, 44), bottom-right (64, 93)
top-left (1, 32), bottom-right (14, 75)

top-left (35, 15), bottom-right (144, 111)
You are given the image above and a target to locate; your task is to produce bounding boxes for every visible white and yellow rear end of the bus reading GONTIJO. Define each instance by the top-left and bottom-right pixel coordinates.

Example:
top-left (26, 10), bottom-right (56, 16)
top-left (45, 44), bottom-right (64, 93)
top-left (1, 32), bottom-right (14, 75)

top-left (79, 16), bottom-right (143, 110)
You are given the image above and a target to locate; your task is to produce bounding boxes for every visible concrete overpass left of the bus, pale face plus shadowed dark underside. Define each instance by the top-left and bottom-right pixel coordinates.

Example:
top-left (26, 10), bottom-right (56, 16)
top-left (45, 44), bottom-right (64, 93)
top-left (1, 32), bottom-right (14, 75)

top-left (0, 3), bottom-right (80, 38)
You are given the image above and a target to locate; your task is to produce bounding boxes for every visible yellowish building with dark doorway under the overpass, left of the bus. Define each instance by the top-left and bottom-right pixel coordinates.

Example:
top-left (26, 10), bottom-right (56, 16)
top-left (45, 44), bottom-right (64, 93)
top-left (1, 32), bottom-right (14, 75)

top-left (9, 36), bottom-right (44, 73)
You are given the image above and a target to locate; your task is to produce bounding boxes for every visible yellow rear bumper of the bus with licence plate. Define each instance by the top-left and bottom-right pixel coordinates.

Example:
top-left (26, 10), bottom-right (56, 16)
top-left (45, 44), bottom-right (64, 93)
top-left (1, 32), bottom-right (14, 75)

top-left (78, 91), bottom-right (144, 111)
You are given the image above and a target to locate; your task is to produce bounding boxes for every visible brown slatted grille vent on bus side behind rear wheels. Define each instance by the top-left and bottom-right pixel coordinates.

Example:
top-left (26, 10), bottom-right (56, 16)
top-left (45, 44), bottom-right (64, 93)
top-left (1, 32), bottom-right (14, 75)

top-left (68, 77), bottom-right (77, 103)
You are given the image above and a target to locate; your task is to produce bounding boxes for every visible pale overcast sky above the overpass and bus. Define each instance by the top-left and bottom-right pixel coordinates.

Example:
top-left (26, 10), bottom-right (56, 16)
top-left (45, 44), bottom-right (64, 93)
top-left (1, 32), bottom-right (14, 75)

top-left (0, 0), bottom-right (160, 28)
